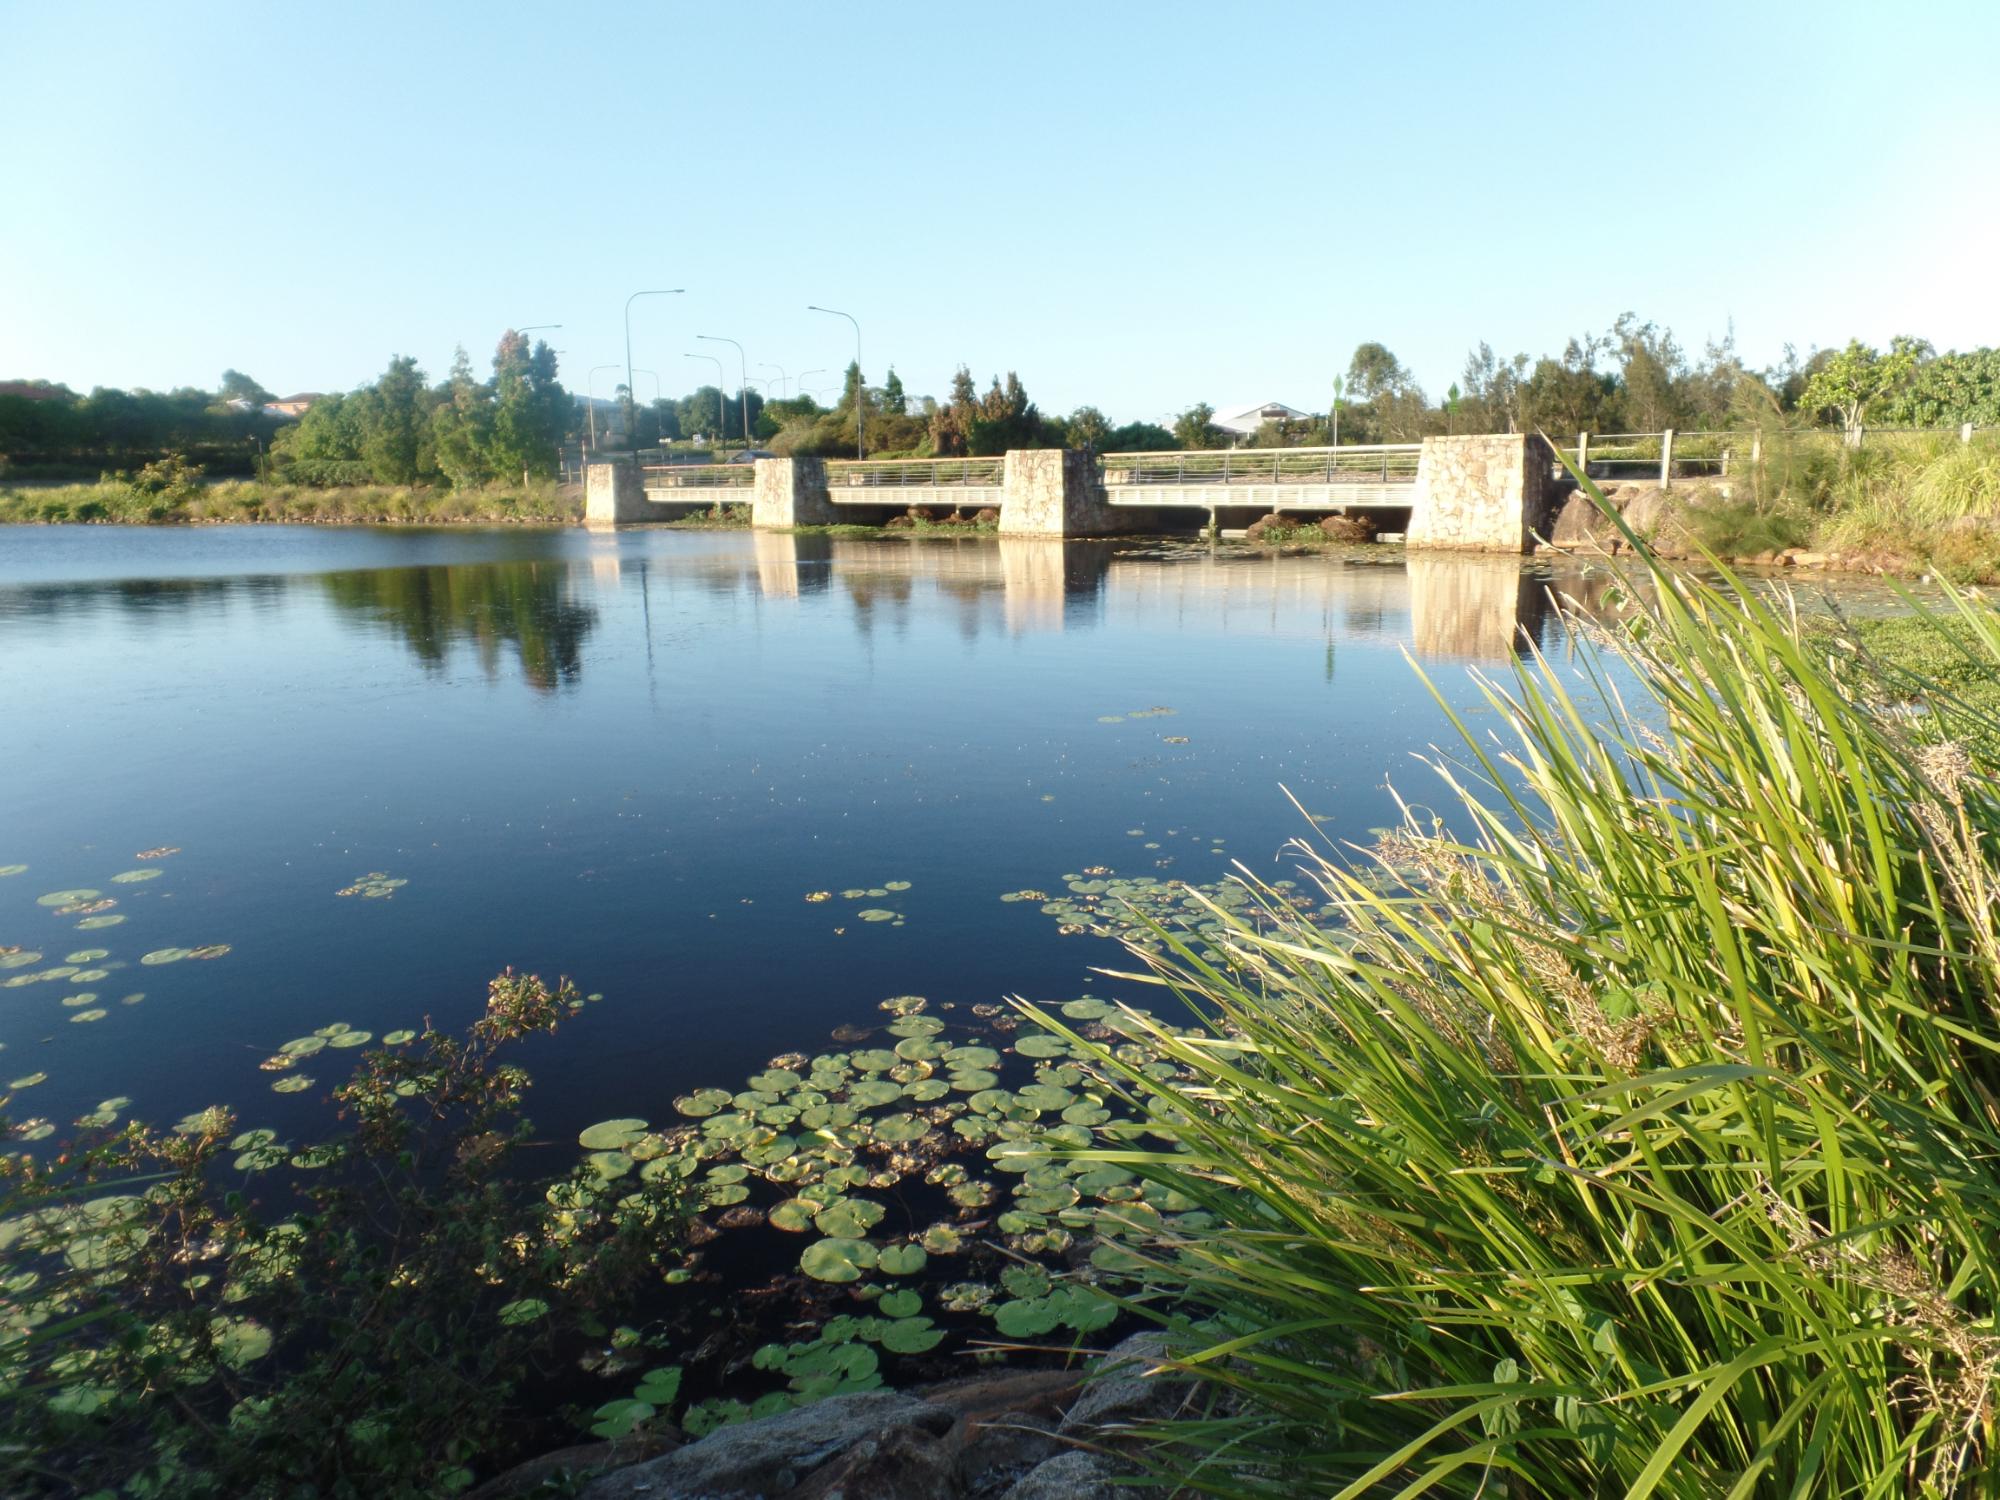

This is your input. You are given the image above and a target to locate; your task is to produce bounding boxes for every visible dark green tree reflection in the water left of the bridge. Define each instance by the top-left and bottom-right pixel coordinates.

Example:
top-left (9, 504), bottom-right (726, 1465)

top-left (320, 562), bottom-right (598, 692)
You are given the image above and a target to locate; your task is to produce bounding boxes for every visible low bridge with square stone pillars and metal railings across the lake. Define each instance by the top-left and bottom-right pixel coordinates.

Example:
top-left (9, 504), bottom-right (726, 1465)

top-left (586, 434), bottom-right (1554, 552)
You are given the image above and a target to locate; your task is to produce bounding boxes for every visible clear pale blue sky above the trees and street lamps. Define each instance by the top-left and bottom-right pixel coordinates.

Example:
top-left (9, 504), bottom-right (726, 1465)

top-left (0, 0), bottom-right (2000, 420)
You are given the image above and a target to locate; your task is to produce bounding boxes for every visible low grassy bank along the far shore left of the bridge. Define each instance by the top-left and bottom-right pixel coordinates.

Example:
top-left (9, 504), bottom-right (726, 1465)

top-left (0, 480), bottom-right (582, 526)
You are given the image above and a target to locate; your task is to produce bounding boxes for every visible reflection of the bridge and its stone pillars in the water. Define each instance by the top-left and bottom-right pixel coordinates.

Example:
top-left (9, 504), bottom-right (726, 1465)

top-left (600, 532), bottom-right (1612, 662)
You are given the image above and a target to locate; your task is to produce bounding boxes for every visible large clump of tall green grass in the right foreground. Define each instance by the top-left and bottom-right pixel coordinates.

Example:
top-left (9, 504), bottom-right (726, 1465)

top-left (1044, 476), bottom-right (2000, 1500)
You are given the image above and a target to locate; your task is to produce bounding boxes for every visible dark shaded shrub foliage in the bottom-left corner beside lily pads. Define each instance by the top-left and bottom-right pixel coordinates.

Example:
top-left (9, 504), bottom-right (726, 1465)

top-left (0, 974), bottom-right (684, 1500)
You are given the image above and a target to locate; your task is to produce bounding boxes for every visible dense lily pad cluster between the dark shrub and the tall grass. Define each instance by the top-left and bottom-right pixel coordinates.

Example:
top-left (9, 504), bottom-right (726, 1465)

top-left (578, 996), bottom-right (1196, 1432)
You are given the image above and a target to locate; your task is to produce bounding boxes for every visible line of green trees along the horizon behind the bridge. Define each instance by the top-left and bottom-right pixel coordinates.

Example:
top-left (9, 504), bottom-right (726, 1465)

top-left (0, 314), bottom-right (2000, 486)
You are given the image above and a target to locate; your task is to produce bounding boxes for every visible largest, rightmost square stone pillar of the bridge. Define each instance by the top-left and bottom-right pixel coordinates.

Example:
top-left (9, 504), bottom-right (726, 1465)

top-left (1404, 432), bottom-right (1556, 554)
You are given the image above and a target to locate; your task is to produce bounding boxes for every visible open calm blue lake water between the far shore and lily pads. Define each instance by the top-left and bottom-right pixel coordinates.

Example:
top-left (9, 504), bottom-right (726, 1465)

top-left (0, 528), bottom-right (1872, 1140)
